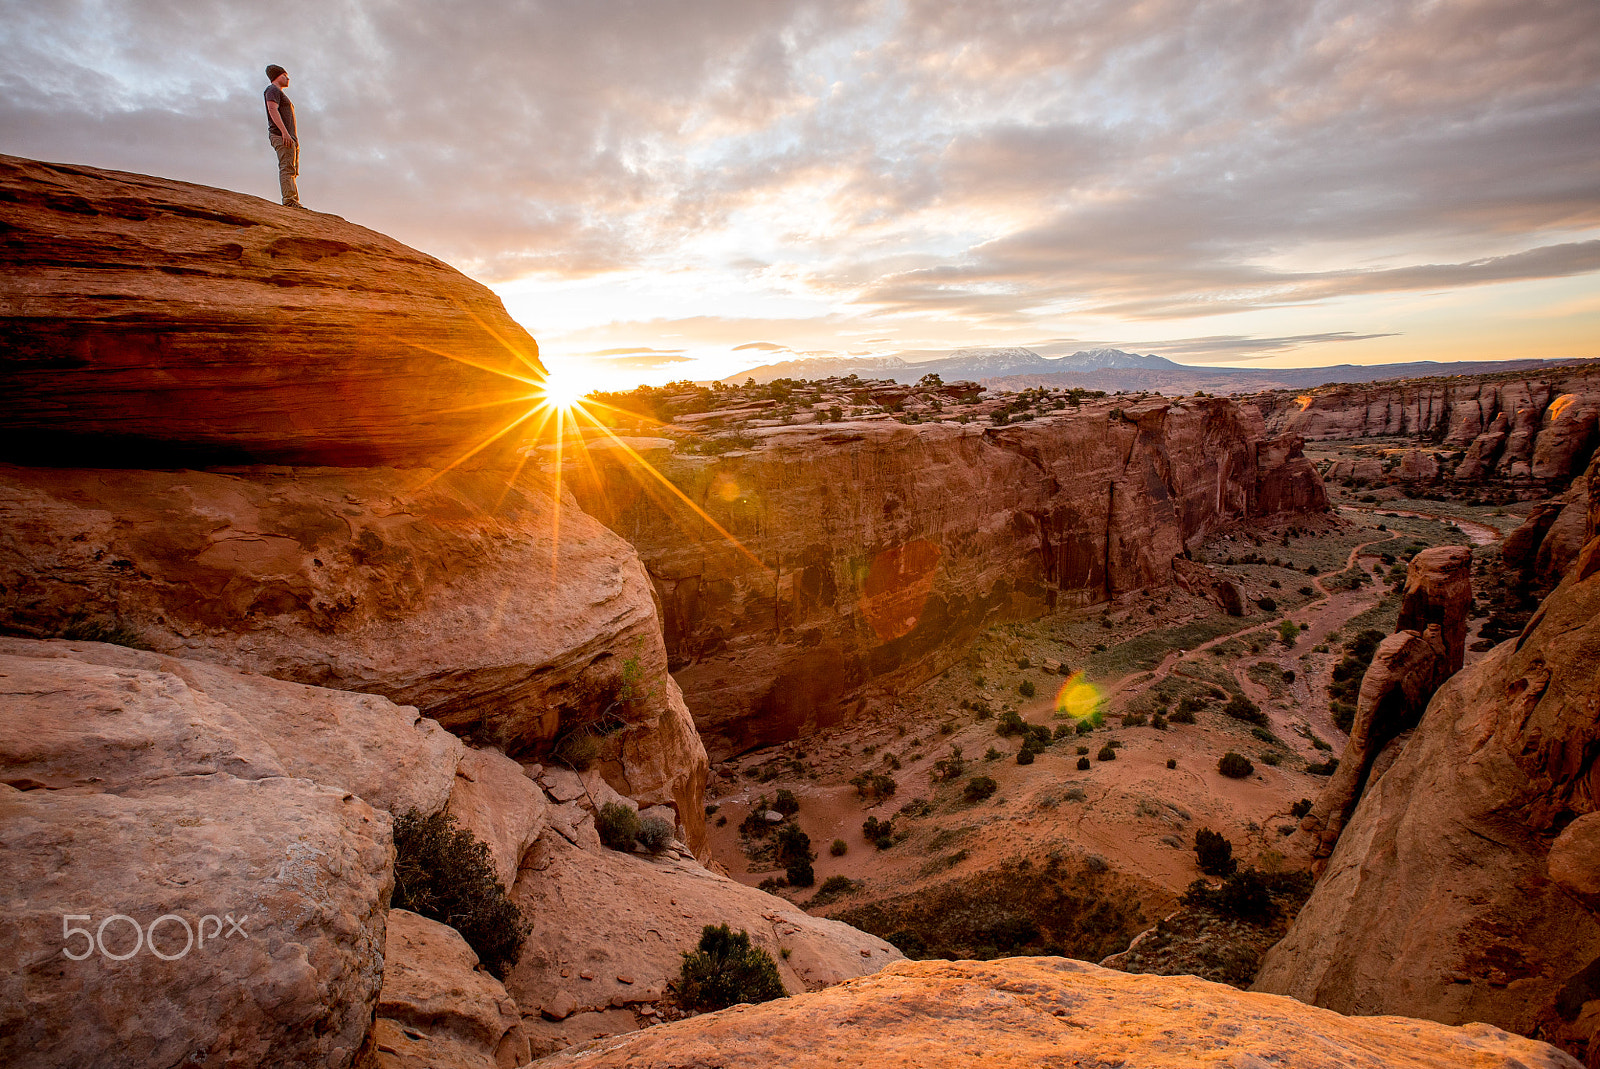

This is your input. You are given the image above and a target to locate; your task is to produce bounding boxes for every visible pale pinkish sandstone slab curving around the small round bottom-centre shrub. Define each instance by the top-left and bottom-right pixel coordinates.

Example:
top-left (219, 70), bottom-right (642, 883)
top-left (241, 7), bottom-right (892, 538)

top-left (506, 835), bottom-right (901, 1053)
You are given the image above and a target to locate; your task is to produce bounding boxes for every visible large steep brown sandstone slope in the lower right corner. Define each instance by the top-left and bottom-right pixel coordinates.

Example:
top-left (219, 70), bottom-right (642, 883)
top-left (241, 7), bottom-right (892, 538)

top-left (1256, 530), bottom-right (1600, 1050)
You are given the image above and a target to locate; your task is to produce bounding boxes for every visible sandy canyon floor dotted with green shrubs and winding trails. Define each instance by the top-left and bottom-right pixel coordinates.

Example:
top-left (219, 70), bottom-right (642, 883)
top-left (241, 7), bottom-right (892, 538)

top-left (707, 440), bottom-right (1533, 979)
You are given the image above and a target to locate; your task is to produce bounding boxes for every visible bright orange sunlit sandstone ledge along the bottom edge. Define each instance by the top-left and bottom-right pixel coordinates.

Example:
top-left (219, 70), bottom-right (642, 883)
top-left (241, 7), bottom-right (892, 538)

top-left (534, 957), bottom-right (1578, 1069)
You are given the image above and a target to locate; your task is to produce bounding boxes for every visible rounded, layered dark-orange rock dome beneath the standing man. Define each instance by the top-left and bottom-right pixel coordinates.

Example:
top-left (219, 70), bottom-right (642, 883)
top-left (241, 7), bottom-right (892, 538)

top-left (0, 157), bottom-right (544, 467)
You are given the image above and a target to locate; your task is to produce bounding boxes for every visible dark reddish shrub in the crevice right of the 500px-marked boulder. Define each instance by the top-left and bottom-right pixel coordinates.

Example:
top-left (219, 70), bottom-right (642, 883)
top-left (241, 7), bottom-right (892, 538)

top-left (390, 810), bottom-right (530, 979)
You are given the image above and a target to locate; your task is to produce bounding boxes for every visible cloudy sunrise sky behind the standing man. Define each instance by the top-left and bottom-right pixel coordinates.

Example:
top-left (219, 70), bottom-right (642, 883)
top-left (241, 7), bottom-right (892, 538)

top-left (0, 0), bottom-right (1600, 382)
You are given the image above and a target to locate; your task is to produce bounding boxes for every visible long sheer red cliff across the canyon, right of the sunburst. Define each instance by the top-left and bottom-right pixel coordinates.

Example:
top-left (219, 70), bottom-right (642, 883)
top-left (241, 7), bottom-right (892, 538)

top-left (570, 400), bottom-right (1326, 754)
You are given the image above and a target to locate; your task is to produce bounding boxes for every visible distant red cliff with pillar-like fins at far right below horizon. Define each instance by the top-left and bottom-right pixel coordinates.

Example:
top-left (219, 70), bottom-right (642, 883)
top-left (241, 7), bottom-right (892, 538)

top-left (1250, 365), bottom-right (1600, 486)
